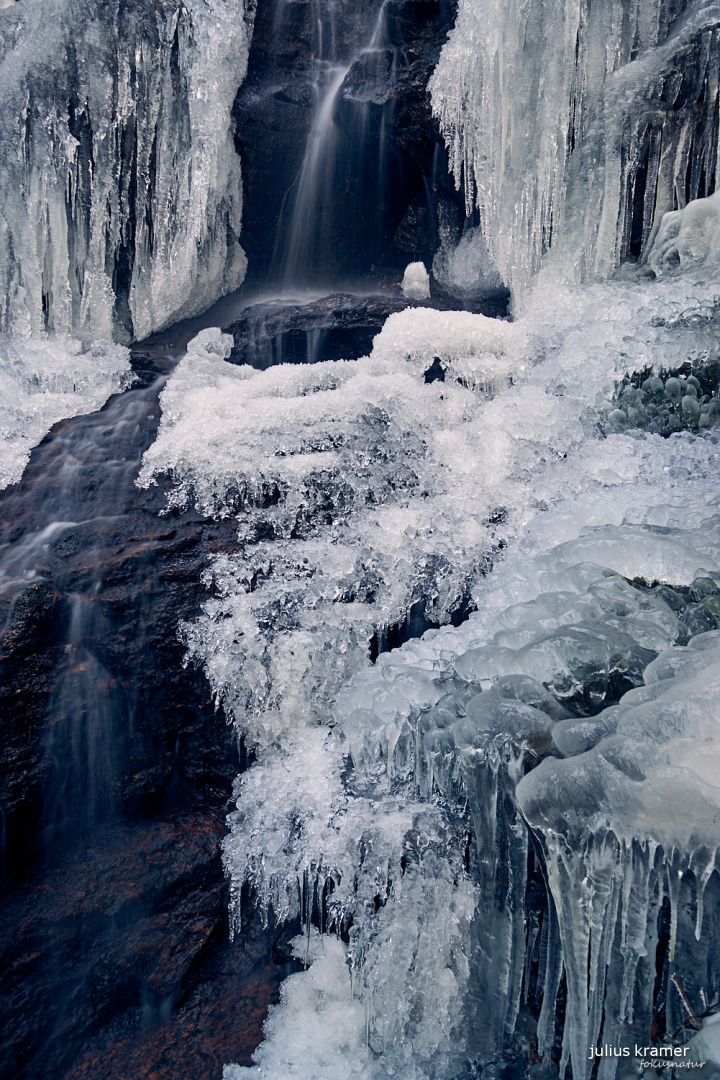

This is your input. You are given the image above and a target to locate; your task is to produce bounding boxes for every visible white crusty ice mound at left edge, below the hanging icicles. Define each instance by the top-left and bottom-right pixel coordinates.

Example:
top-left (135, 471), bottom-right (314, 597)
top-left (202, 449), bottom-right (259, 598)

top-left (0, 337), bottom-right (132, 489)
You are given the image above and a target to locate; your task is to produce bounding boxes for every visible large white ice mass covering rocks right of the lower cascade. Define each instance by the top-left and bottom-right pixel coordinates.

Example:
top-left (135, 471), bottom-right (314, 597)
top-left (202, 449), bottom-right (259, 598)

top-left (140, 263), bottom-right (720, 1080)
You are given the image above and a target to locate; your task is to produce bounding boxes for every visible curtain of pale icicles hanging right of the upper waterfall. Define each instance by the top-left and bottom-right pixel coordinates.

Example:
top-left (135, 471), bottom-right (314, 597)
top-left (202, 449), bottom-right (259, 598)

top-left (431, 0), bottom-right (720, 288)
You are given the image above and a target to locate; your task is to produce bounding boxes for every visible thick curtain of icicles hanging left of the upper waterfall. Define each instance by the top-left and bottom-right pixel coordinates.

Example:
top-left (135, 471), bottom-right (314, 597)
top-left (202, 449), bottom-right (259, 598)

top-left (0, 0), bottom-right (254, 339)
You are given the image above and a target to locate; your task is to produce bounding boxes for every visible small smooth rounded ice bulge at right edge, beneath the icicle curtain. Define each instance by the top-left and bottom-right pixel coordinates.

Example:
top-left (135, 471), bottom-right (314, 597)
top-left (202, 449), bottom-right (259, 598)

top-left (648, 191), bottom-right (720, 276)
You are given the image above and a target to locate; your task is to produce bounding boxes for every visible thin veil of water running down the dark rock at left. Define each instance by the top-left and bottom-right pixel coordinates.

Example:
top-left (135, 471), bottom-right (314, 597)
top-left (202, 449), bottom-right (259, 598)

top-left (0, 362), bottom-right (174, 876)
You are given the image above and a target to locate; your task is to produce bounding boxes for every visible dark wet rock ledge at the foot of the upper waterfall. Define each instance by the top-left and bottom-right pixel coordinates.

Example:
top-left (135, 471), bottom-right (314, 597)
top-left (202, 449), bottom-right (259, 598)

top-left (226, 289), bottom-right (507, 370)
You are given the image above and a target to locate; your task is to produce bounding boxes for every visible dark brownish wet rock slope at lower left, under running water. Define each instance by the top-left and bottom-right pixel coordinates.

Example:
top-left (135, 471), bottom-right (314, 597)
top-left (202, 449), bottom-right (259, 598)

top-left (0, 356), bottom-right (282, 1080)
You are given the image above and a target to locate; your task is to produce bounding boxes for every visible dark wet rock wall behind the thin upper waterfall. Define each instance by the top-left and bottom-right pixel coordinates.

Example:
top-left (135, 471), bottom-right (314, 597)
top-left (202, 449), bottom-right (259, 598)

top-left (234, 0), bottom-right (464, 284)
